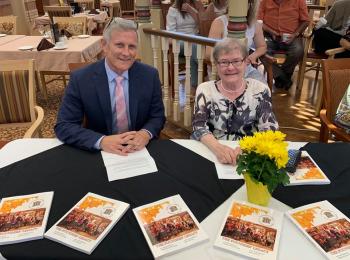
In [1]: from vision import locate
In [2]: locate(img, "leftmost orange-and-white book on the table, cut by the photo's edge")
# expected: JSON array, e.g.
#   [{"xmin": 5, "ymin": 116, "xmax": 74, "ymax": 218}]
[{"xmin": 0, "ymin": 191, "xmax": 53, "ymax": 245}]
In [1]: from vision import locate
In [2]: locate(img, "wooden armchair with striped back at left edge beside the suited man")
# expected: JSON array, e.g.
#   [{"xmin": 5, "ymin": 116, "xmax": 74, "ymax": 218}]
[{"xmin": 0, "ymin": 60, "xmax": 44, "ymax": 138}]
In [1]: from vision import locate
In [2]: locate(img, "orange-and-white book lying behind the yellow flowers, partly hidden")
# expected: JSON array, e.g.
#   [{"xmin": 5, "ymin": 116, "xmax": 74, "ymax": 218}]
[{"xmin": 287, "ymin": 151, "xmax": 331, "ymax": 186}]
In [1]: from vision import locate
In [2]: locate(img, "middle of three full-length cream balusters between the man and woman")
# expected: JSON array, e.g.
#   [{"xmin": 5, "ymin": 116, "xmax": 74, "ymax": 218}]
[{"xmin": 173, "ymin": 39, "xmax": 180, "ymax": 121}]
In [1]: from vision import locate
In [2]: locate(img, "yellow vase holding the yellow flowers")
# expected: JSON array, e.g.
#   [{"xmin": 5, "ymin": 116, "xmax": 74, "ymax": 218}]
[{"xmin": 244, "ymin": 174, "xmax": 271, "ymax": 206}]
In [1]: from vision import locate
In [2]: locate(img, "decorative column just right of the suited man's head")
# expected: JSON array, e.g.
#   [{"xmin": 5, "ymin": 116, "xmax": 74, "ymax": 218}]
[{"xmin": 135, "ymin": 0, "xmax": 153, "ymax": 66}]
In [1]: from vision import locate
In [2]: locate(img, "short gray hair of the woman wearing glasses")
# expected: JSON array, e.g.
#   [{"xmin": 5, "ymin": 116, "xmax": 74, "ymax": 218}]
[{"xmin": 213, "ymin": 38, "xmax": 248, "ymax": 62}]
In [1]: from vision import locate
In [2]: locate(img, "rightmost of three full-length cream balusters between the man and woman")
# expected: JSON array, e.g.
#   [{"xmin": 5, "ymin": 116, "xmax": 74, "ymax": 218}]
[{"xmin": 184, "ymin": 41, "xmax": 192, "ymax": 126}]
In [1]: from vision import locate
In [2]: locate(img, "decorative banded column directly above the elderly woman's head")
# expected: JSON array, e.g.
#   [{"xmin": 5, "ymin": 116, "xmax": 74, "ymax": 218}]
[{"xmin": 227, "ymin": 0, "xmax": 248, "ymax": 39}]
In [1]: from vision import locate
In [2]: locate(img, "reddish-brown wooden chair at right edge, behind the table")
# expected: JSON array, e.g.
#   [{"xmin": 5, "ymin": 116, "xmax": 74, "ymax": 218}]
[{"xmin": 320, "ymin": 58, "xmax": 350, "ymax": 142}]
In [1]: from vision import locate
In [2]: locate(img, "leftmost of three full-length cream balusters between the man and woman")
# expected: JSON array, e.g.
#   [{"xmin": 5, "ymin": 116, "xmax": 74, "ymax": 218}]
[{"xmin": 161, "ymin": 37, "xmax": 170, "ymax": 116}]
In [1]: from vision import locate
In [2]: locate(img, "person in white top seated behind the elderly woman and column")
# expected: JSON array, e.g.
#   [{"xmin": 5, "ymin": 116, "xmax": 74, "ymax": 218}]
[{"xmin": 206, "ymin": 0, "xmax": 267, "ymax": 84}]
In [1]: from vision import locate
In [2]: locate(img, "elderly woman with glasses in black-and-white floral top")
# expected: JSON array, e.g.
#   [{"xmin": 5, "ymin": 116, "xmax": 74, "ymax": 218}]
[{"xmin": 192, "ymin": 38, "xmax": 278, "ymax": 164}]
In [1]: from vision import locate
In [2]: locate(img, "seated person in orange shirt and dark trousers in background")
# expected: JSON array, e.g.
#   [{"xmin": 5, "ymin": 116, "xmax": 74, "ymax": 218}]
[{"xmin": 257, "ymin": 0, "xmax": 309, "ymax": 90}]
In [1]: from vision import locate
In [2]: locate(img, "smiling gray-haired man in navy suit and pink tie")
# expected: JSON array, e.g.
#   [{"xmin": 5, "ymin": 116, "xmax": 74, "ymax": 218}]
[{"xmin": 55, "ymin": 18, "xmax": 165, "ymax": 155}]
